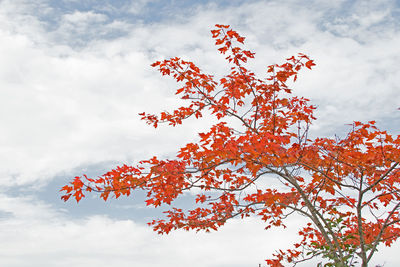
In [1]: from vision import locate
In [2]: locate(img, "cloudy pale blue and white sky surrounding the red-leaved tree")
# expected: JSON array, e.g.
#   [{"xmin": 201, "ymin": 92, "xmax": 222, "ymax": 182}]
[{"xmin": 0, "ymin": 0, "xmax": 400, "ymax": 267}]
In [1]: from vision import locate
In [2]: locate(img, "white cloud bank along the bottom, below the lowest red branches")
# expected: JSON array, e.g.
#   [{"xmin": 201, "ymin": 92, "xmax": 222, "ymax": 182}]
[{"xmin": 0, "ymin": 195, "xmax": 304, "ymax": 267}]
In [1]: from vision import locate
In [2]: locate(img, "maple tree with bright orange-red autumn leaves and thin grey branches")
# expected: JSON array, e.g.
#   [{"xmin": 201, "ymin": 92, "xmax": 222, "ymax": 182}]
[{"xmin": 61, "ymin": 25, "xmax": 400, "ymax": 266}]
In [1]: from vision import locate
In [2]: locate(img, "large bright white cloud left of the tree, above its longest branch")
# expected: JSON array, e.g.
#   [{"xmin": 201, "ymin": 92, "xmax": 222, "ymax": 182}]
[{"xmin": 0, "ymin": 1, "xmax": 222, "ymax": 188}]
